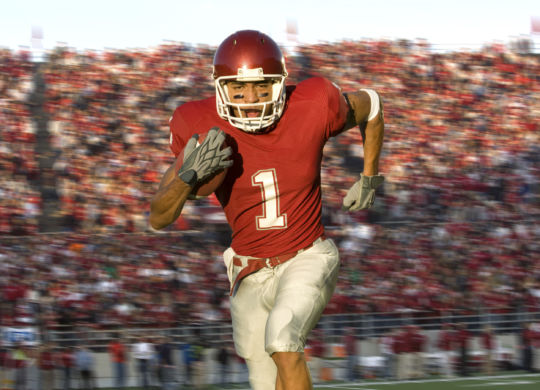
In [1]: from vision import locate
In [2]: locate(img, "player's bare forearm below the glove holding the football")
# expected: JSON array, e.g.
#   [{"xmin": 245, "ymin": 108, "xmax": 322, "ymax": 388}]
[{"xmin": 150, "ymin": 177, "xmax": 192, "ymax": 230}]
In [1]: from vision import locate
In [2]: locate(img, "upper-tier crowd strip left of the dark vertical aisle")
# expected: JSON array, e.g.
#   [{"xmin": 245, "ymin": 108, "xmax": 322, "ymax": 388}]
[{"xmin": 0, "ymin": 49, "xmax": 41, "ymax": 234}]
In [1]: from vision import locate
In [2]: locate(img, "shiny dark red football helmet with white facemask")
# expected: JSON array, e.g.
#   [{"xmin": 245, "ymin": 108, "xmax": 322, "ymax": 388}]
[{"xmin": 213, "ymin": 30, "xmax": 287, "ymax": 132}]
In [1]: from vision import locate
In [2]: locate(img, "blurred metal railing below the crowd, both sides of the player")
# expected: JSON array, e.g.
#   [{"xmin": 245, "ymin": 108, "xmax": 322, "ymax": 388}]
[{"xmin": 41, "ymin": 308, "xmax": 540, "ymax": 350}]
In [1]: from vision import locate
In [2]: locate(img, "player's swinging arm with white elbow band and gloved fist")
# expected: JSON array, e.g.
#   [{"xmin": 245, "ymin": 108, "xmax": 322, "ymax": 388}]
[{"xmin": 343, "ymin": 90, "xmax": 384, "ymax": 211}]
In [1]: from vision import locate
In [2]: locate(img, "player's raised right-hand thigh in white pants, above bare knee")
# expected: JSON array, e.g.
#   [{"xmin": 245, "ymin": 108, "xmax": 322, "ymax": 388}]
[{"xmin": 266, "ymin": 240, "xmax": 339, "ymax": 355}]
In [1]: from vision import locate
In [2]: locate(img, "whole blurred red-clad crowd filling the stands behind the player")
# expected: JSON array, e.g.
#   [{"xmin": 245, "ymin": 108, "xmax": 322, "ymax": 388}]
[{"xmin": 0, "ymin": 41, "xmax": 540, "ymax": 328}]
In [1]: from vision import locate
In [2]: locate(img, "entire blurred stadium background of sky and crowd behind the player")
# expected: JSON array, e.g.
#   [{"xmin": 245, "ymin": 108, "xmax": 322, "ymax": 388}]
[{"xmin": 0, "ymin": 1, "xmax": 540, "ymax": 386}]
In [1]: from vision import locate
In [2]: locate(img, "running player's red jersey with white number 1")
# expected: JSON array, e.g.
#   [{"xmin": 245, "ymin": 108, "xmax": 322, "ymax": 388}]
[{"xmin": 170, "ymin": 77, "xmax": 349, "ymax": 258}]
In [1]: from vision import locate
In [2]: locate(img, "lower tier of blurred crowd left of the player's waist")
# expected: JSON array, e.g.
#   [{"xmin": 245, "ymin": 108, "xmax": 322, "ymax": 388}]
[{"xmin": 0, "ymin": 234, "xmax": 229, "ymax": 331}]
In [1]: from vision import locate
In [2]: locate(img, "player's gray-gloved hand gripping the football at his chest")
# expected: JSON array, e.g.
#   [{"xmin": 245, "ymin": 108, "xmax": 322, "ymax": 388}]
[{"xmin": 178, "ymin": 127, "xmax": 233, "ymax": 186}]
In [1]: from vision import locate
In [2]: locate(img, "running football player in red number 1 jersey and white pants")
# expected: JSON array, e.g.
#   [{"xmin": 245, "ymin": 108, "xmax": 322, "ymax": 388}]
[{"xmin": 150, "ymin": 30, "xmax": 384, "ymax": 390}]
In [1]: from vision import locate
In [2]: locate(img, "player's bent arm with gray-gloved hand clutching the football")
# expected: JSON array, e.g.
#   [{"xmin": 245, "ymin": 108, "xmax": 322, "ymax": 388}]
[{"xmin": 150, "ymin": 128, "xmax": 233, "ymax": 229}]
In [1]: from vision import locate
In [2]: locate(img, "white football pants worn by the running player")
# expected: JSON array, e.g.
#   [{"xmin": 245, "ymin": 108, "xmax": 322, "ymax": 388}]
[{"xmin": 223, "ymin": 239, "xmax": 339, "ymax": 390}]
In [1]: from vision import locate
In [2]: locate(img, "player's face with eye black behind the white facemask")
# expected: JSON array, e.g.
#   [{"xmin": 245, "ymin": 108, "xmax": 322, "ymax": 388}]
[{"xmin": 227, "ymin": 80, "xmax": 273, "ymax": 118}]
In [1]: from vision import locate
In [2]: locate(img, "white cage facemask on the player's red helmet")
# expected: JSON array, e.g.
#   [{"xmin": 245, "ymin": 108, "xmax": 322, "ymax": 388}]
[{"xmin": 215, "ymin": 68, "xmax": 287, "ymax": 133}]
